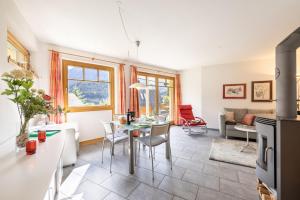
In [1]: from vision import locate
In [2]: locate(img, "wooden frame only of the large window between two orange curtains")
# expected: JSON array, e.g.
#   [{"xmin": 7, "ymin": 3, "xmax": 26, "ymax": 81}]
[{"xmin": 62, "ymin": 60, "xmax": 115, "ymax": 113}]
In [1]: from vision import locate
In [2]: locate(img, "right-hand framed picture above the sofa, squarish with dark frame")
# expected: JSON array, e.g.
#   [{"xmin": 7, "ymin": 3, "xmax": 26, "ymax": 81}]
[{"xmin": 251, "ymin": 81, "xmax": 273, "ymax": 102}]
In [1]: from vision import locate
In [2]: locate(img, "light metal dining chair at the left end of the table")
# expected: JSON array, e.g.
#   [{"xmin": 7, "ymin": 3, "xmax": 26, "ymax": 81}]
[{"xmin": 102, "ymin": 122, "xmax": 128, "ymax": 173}]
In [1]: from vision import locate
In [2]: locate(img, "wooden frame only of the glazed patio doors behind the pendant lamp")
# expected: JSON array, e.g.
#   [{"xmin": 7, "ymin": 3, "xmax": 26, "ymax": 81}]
[{"xmin": 137, "ymin": 71, "xmax": 175, "ymax": 122}]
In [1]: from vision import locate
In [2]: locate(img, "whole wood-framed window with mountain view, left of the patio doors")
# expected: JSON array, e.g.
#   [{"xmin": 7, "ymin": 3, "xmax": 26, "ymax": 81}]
[{"xmin": 63, "ymin": 60, "xmax": 114, "ymax": 112}]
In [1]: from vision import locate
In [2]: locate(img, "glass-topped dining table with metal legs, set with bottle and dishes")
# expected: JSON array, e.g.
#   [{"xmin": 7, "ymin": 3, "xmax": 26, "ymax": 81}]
[{"xmin": 113, "ymin": 120, "xmax": 170, "ymax": 174}]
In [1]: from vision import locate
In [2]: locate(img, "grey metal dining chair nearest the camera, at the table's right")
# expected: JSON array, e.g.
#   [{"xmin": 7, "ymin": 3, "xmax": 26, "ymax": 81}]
[{"xmin": 136, "ymin": 123, "xmax": 172, "ymax": 180}]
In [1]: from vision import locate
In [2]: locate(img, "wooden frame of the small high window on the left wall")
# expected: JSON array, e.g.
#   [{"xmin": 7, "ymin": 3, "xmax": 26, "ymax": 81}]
[{"xmin": 6, "ymin": 31, "xmax": 30, "ymax": 69}]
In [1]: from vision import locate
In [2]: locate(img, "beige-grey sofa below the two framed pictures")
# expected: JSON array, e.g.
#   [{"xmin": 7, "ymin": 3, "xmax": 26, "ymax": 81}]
[{"xmin": 219, "ymin": 108, "xmax": 275, "ymax": 139}]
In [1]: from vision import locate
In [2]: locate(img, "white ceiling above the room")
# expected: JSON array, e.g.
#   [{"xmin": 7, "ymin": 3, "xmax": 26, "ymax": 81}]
[{"xmin": 15, "ymin": 0, "xmax": 300, "ymax": 69}]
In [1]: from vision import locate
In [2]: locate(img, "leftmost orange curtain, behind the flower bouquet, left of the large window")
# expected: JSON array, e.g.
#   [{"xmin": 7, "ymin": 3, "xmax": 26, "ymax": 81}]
[{"xmin": 50, "ymin": 51, "xmax": 64, "ymax": 124}]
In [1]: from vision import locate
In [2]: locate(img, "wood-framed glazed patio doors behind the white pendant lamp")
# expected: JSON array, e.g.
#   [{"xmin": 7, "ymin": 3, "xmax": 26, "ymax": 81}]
[{"xmin": 138, "ymin": 72, "xmax": 174, "ymax": 120}]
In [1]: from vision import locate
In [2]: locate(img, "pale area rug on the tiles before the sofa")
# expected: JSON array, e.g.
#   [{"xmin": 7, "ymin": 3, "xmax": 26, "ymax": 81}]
[{"xmin": 209, "ymin": 138, "xmax": 257, "ymax": 168}]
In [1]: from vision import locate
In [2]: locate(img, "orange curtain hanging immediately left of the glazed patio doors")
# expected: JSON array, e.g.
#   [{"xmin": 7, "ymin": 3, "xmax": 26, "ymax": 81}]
[{"xmin": 129, "ymin": 65, "xmax": 140, "ymax": 117}]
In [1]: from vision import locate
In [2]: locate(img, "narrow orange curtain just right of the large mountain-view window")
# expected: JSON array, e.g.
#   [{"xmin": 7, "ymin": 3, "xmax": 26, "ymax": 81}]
[{"xmin": 119, "ymin": 64, "xmax": 126, "ymax": 114}]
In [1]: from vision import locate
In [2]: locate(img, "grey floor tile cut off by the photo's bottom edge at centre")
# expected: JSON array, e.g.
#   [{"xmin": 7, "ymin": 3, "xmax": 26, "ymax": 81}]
[{"xmin": 129, "ymin": 183, "xmax": 172, "ymax": 200}]
